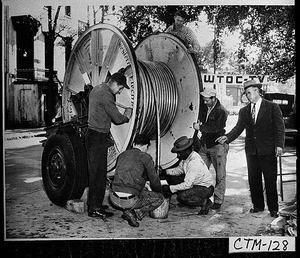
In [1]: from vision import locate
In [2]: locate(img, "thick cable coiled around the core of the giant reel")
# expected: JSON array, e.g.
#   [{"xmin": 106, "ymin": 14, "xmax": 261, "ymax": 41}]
[{"xmin": 137, "ymin": 60, "xmax": 178, "ymax": 139}]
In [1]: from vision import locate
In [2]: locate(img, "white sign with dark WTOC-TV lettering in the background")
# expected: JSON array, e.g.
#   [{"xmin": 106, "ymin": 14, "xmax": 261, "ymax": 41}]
[{"xmin": 202, "ymin": 73, "xmax": 269, "ymax": 85}]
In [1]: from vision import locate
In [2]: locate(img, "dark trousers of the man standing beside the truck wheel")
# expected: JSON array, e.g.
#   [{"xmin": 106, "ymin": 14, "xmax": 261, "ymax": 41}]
[{"xmin": 85, "ymin": 129, "xmax": 109, "ymax": 211}]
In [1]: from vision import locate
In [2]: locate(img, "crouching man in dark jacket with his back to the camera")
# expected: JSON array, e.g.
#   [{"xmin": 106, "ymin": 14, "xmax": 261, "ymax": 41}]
[{"xmin": 110, "ymin": 135, "xmax": 164, "ymax": 227}]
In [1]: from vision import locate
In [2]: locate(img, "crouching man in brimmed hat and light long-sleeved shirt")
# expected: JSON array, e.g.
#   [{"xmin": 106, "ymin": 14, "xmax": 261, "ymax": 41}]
[{"xmin": 161, "ymin": 136, "xmax": 214, "ymax": 215}]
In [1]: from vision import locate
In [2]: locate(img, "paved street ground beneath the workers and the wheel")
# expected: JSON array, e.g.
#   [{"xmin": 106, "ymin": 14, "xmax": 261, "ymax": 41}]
[{"xmin": 5, "ymin": 116, "xmax": 296, "ymax": 239}]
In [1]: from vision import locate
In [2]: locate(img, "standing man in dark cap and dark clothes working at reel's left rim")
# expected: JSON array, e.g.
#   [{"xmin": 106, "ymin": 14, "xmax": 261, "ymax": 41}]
[{"xmin": 85, "ymin": 73, "xmax": 132, "ymax": 221}]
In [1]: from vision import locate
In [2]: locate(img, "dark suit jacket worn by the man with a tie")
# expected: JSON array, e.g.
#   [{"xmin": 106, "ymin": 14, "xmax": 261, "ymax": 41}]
[{"xmin": 226, "ymin": 99, "xmax": 284, "ymax": 155}]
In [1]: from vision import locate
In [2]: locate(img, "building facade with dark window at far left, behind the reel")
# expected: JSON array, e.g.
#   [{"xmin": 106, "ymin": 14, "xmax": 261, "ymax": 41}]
[{"xmin": 2, "ymin": 5, "xmax": 84, "ymax": 128}]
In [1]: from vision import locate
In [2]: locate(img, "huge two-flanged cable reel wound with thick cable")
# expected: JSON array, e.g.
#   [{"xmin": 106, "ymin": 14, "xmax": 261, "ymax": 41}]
[{"xmin": 63, "ymin": 24, "xmax": 202, "ymax": 170}]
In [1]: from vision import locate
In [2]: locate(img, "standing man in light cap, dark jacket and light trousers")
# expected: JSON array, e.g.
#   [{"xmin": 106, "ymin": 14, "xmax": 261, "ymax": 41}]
[{"xmin": 194, "ymin": 88, "xmax": 229, "ymax": 209}]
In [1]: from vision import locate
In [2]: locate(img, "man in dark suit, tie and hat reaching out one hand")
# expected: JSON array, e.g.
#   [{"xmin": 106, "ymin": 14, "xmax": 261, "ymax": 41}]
[{"xmin": 217, "ymin": 80, "xmax": 284, "ymax": 217}]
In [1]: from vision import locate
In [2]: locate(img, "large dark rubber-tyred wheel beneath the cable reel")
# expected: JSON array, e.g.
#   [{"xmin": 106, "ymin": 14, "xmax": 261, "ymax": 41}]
[{"xmin": 42, "ymin": 133, "xmax": 88, "ymax": 206}]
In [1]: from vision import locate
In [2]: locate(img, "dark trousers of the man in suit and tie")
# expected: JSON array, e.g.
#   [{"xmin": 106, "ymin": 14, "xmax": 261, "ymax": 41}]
[{"xmin": 246, "ymin": 153, "xmax": 278, "ymax": 211}]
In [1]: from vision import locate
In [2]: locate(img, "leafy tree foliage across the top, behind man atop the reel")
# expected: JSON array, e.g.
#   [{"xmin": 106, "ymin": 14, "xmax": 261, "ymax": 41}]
[{"xmin": 121, "ymin": 5, "xmax": 296, "ymax": 81}]
